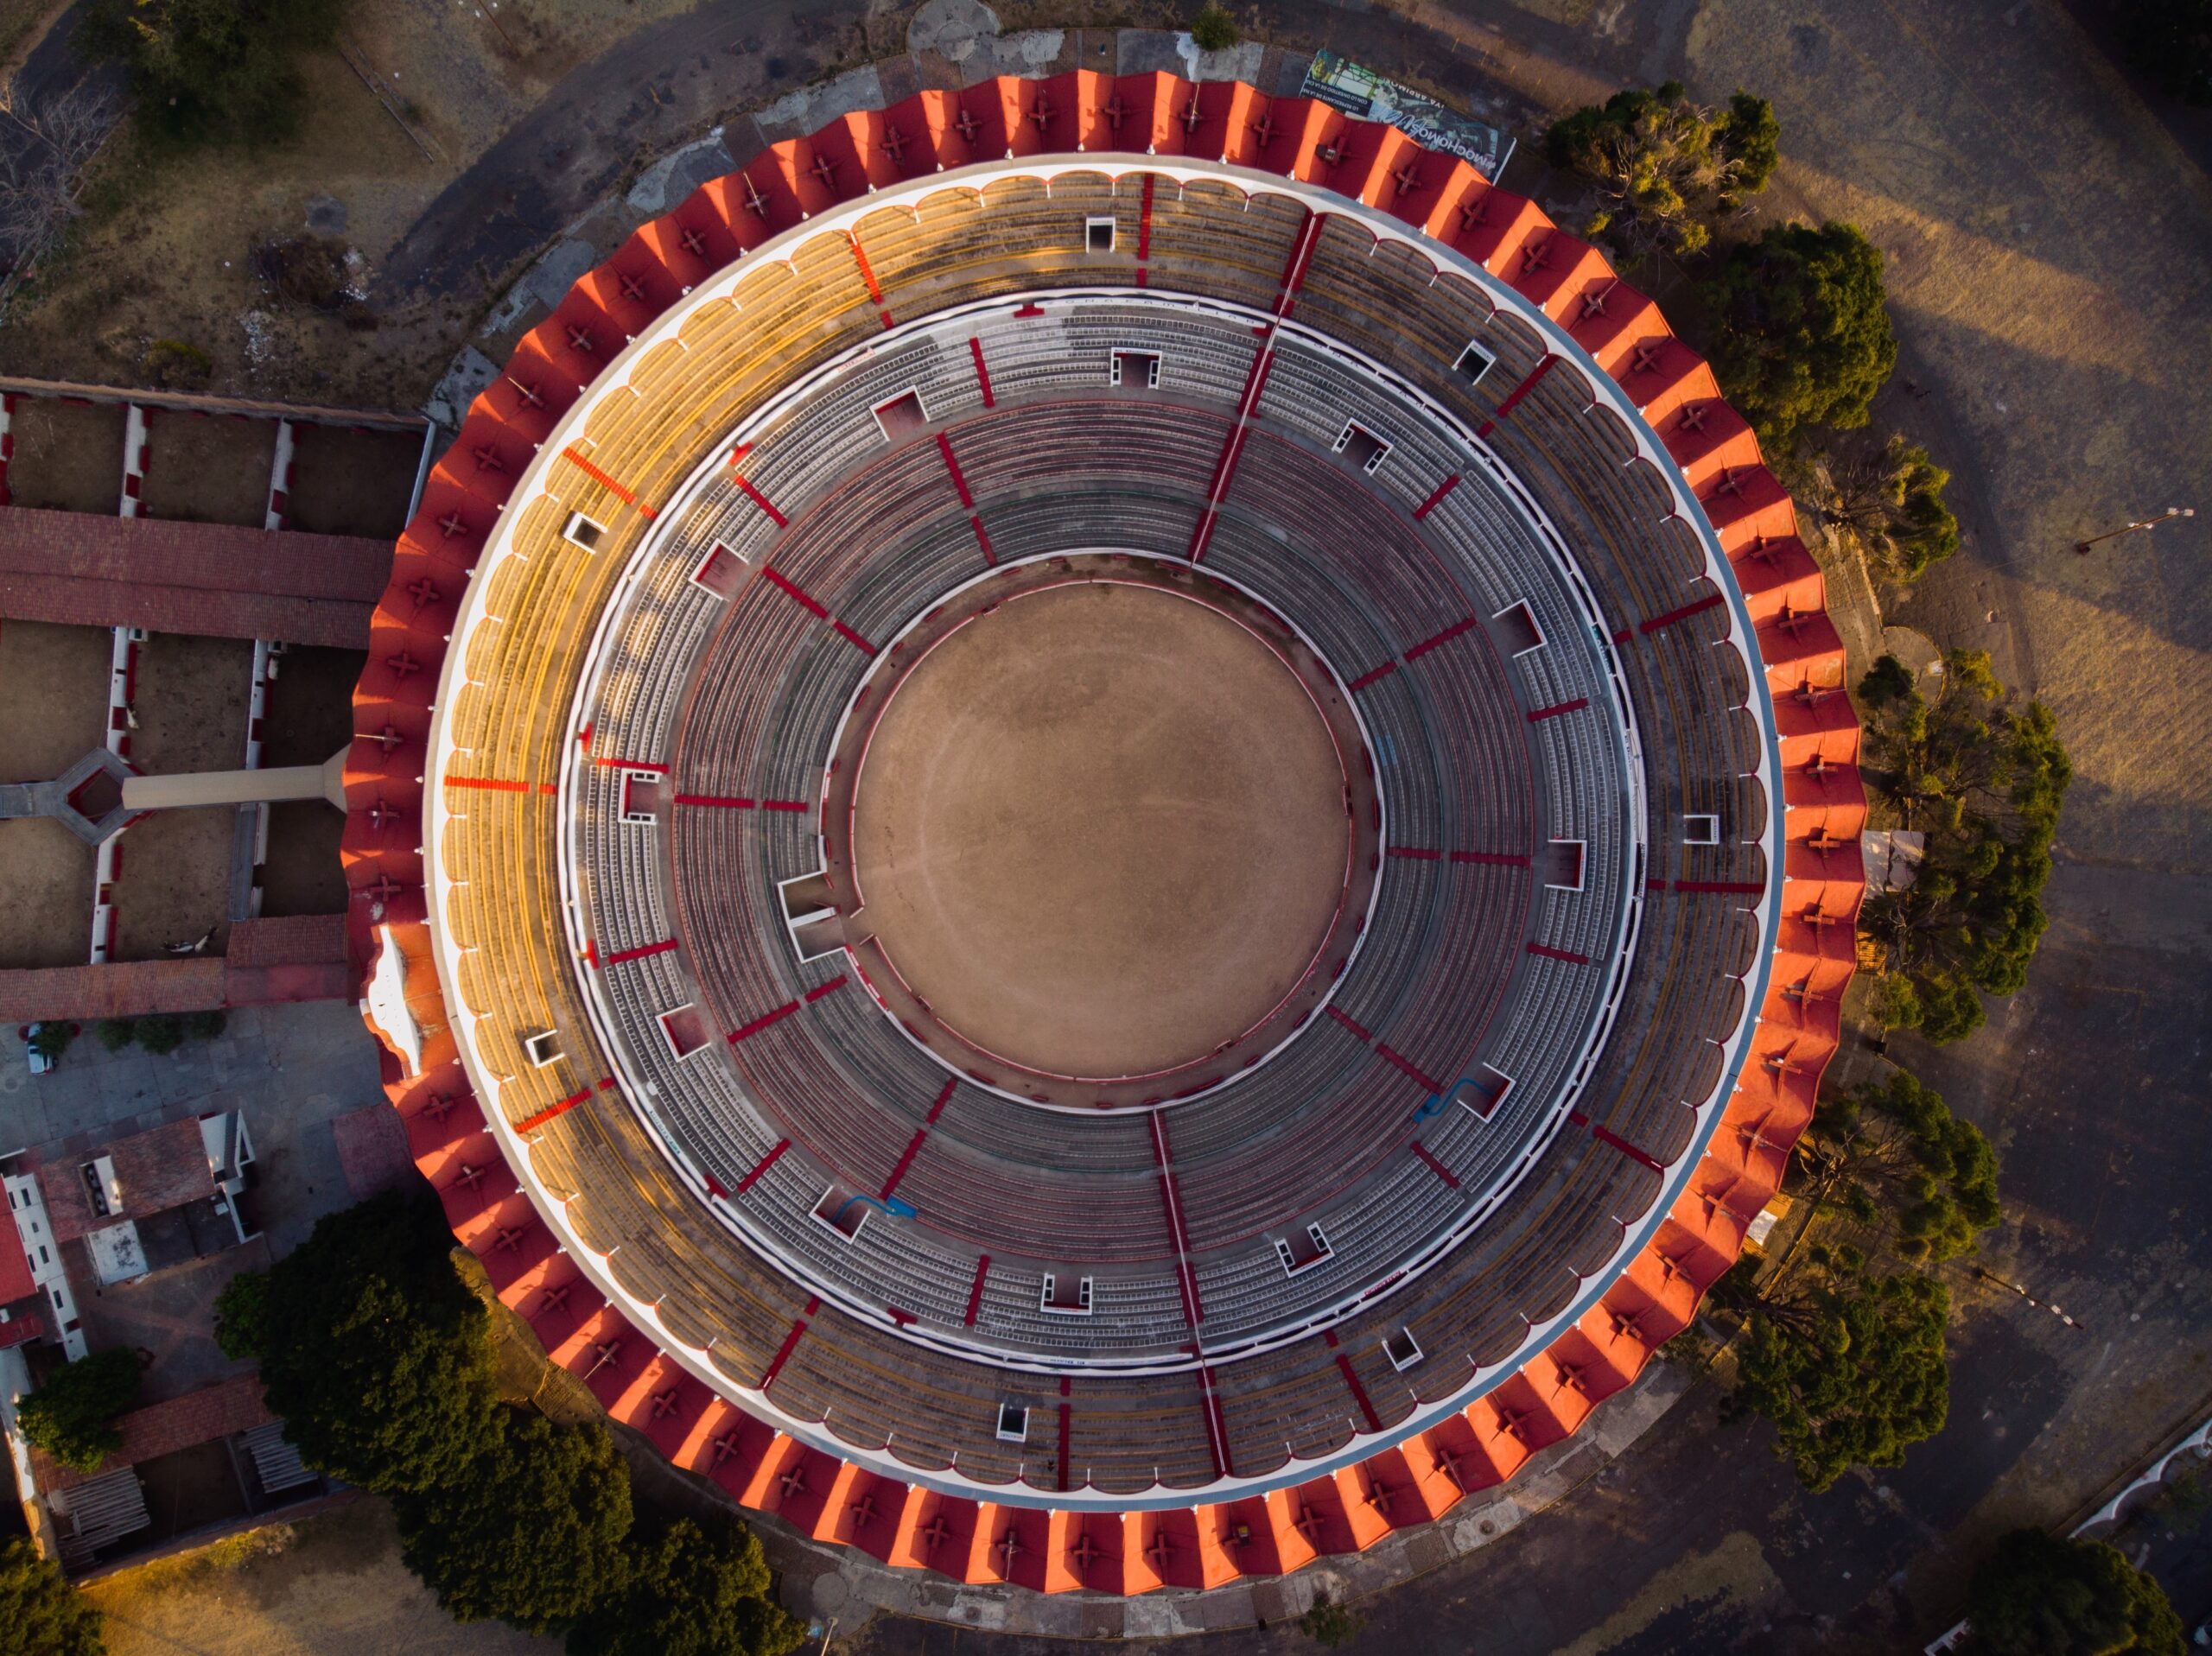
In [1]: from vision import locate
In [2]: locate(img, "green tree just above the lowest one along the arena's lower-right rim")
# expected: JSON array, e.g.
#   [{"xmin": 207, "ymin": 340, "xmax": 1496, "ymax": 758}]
[{"xmin": 1808, "ymin": 1070, "xmax": 2002, "ymax": 1265}]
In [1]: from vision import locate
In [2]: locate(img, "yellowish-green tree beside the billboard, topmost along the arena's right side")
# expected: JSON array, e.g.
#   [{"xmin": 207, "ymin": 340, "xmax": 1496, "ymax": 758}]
[{"xmin": 1544, "ymin": 79, "xmax": 1781, "ymax": 254}]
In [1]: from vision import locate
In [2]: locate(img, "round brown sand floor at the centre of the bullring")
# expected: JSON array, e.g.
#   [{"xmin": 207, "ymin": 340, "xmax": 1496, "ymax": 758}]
[{"xmin": 854, "ymin": 584, "xmax": 1350, "ymax": 1076}]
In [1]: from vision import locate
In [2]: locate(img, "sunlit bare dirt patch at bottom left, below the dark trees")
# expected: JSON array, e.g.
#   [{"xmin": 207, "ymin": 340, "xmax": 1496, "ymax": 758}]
[{"xmin": 84, "ymin": 1497, "xmax": 560, "ymax": 1656}]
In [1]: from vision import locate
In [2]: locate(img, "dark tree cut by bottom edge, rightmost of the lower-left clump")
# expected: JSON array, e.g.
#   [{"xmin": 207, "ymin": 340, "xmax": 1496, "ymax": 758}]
[{"xmin": 569, "ymin": 1519, "xmax": 805, "ymax": 1656}]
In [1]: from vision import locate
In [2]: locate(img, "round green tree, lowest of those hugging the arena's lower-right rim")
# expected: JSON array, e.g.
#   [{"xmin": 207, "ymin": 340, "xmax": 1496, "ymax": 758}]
[{"xmin": 1721, "ymin": 1242, "xmax": 1951, "ymax": 1494}]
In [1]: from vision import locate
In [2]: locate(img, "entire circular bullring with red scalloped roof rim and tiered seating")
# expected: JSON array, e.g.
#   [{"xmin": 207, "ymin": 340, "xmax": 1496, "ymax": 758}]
[{"xmin": 345, "ymin": 73, "xmax": 1865, "ymax": 1592}]
